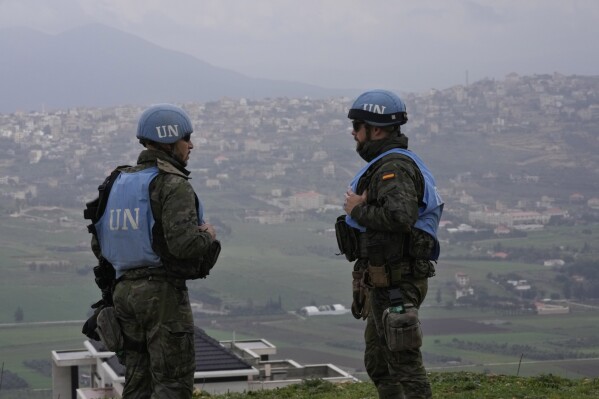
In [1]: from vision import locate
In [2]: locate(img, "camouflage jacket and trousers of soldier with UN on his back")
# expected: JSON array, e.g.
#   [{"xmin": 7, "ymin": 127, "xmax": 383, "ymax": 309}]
[{"xmin": 92, "ymin": 150, "xmax": 212, "ymax": 399}]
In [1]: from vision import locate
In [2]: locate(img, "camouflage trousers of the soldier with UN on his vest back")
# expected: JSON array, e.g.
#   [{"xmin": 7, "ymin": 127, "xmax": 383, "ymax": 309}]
[{"xmin": 113, "ymin": 270, "xmax": 195, "ymax": 399}]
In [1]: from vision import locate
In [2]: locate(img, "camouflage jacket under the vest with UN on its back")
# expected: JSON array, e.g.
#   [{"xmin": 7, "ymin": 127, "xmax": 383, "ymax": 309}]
[{"xmin": 92, "ymin": 150, "xmax": 212, "ymax": 263}]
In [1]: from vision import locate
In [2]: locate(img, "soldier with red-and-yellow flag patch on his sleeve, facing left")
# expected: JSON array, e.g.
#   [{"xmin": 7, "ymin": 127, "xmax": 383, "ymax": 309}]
[{"xmin": 335, "ymin": 90, "xmax": 443, "ymax": 399}]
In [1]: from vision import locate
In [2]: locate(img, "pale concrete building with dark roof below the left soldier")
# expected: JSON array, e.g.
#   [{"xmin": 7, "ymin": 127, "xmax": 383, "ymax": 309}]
[{"xmin": 52, "ymin": 327, "xmax": 358, "ymax": 399}]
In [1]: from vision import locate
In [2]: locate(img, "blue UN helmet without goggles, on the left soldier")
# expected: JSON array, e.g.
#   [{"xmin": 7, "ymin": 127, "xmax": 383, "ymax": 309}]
[{"xmin": 137, "ymin": 104, "xmax": 193, "ymax": 144}]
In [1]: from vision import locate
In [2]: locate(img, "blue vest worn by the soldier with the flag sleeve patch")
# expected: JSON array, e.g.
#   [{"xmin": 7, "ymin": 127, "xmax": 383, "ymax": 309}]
[{"xmin": 345, "ymin": 148, "xmax": 444, "ymax": 260}]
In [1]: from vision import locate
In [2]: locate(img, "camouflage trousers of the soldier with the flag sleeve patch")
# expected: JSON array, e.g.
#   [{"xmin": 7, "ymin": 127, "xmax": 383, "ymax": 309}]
[{"xmin": 364, "ymin": 276, "xmax": 432, "ymax": 399}]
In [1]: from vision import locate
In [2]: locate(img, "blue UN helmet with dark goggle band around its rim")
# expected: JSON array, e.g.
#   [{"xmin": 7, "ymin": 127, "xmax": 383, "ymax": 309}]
[{"xmin": 347, "ymin": 90, "xmax": 408, "ymax": 126}]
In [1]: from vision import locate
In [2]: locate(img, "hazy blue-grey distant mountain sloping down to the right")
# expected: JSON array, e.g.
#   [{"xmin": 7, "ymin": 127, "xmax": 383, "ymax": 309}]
[{"xmin": 0, "ymin": 24, "xmax": 355, "ymax": 113}]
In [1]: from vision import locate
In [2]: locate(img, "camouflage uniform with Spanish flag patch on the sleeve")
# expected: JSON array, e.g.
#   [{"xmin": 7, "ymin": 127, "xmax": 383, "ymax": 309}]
[{"xmin": 351, "ymin": 135, "xmax": 434, "ymax": 399}]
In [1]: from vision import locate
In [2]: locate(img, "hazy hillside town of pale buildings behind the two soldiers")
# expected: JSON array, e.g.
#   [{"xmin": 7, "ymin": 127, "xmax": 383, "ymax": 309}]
[{"xmin": 0, "ymin": 74, "xmax": 599, "ymax": 223}]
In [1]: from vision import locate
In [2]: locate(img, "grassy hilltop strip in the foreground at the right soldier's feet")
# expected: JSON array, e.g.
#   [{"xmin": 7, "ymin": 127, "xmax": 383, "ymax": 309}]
[{"xmin": 194, "ymin": 372, "xmax": 599, "ymax": 399}]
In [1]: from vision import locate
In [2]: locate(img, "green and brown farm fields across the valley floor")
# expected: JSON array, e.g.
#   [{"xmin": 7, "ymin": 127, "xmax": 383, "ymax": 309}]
[{"xmin": 0, "ymin": 209, "xmax": 599, "ymax": 397}]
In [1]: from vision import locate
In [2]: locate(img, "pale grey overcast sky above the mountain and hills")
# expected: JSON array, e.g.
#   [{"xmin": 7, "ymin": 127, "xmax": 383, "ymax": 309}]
[{"xmin": 0, "ymin": 0, "xmax": 599, "ymax": 91}]
